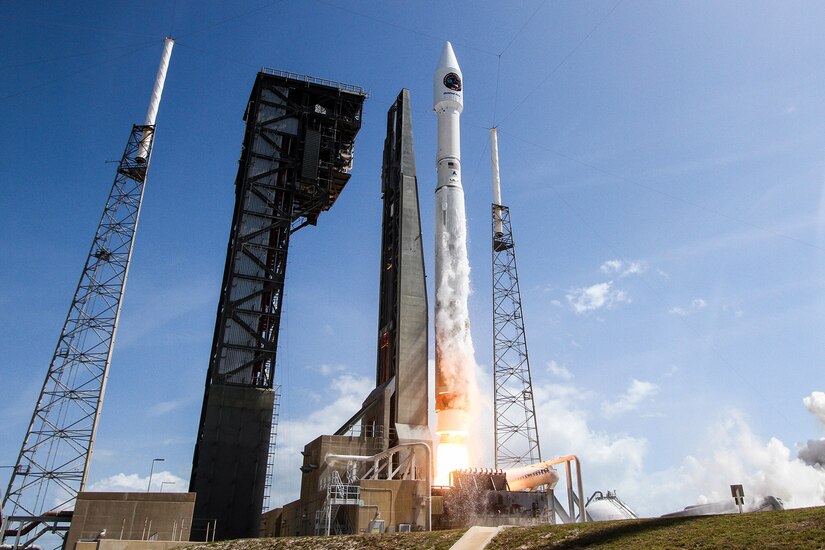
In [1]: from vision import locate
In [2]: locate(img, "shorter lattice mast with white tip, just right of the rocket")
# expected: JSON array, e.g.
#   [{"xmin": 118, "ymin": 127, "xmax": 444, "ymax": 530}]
[{"xmin": 490, "ymin": 128, "xmax": 541, "ymax": 468}]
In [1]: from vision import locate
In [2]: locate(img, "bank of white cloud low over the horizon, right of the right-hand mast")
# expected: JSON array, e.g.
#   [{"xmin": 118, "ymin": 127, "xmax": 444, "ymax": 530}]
[{"xmin": 534, "ymin": 383, "xmax": 825, "ymax": 517}]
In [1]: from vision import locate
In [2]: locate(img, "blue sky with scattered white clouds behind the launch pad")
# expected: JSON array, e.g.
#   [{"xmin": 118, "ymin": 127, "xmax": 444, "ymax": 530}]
[{"xmin": 0, "ymin": 0, "xmax": 825, "ymax": 515}]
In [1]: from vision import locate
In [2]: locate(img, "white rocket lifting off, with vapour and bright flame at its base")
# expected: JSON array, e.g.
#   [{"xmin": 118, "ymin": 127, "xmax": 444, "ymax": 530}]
[{"xmin": 433, "ymin": 42, "xmax": 475, "ymax": 485}]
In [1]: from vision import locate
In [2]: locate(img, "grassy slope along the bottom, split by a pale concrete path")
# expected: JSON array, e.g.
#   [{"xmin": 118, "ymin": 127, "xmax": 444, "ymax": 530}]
[{"xmin": 185, "ymin": 507, "xmax": 825, "ymax": 550}]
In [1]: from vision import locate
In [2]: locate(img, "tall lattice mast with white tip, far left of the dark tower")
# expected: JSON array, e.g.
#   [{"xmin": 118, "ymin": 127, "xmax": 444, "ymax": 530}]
[{"xmin": 0, "ymin": 38, "xmax": 174, "ymax": 548}]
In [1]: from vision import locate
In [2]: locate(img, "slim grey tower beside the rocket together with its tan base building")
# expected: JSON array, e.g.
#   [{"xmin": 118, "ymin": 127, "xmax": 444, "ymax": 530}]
[{"xmin": 274, "ymin": 90, "xmax": 432, "ymax": 536}]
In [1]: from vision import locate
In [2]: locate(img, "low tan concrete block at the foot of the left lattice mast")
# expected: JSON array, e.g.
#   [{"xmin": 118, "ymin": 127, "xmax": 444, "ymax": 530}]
[{"xmin": 65, "ymin": 492, "xmax": 195, "ymax": 550}]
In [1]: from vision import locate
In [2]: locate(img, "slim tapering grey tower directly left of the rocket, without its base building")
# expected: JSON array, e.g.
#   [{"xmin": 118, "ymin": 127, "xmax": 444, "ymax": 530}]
[{"xmin": 337, "ymin": 89, "xmax": 431, "ymax": 450}]
